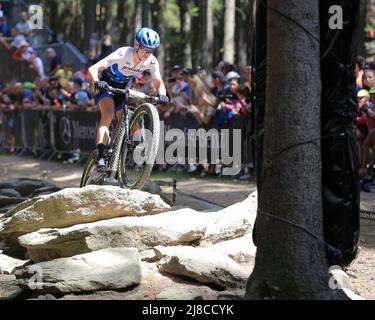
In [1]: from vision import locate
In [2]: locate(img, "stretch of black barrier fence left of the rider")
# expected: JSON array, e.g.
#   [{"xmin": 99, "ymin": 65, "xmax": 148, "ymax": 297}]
[{"xmin": 0, "ymin": 110, "xmax": 100, "ymax": 157}]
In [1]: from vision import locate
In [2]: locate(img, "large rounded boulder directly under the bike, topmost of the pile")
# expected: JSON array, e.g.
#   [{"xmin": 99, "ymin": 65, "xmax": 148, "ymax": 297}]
[{"xmin": 0, "ymin": 186, "xmax": 170, "ymax": 252}]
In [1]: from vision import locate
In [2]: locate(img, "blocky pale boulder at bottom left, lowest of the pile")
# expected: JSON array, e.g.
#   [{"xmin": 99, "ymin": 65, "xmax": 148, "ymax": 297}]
[{"xmin": 15, "ymin": 248, "xmax": 142, "ymax": 294}]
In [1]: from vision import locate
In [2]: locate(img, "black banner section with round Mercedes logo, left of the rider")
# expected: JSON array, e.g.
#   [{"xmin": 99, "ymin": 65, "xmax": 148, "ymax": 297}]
[{"xmin": 53, "ymin": 111, "xmax": 100, "ymax": 153}]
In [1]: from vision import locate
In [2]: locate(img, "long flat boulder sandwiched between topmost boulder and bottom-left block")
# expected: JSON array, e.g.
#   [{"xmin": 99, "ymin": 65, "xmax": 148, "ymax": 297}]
[{"xmin": 19, "ymin": 209, "xmax": 207, "ymax": 262}]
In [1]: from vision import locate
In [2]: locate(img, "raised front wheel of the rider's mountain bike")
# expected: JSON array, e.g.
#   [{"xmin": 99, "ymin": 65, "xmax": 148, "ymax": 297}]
[{"xmin": 118, "ymin": 103, "xmax": 160, "ymax": 189}]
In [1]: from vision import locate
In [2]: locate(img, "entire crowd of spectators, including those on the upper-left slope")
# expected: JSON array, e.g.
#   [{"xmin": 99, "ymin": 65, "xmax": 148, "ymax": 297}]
[{"xmin": 0, "ymin": 4, "xmax": 251, "ymax": 179}]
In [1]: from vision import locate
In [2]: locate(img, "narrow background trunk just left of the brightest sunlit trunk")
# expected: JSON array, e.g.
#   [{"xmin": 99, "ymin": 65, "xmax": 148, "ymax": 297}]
[{"xmin": 201, "ymin": 0, "xmax": 214, "ymax": 69}]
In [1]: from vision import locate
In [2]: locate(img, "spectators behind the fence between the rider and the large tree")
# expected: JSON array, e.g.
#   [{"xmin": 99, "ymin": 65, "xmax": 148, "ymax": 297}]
[{"xmin": 159, "ymin": 61, "xmax": 252, "ymax": 180}]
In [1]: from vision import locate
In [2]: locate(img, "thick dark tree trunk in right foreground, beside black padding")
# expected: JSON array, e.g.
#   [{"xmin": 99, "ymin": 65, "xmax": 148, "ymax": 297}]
[{"xmin": 246, "ymin": 0, "xmax": 344, "ymax": 299}]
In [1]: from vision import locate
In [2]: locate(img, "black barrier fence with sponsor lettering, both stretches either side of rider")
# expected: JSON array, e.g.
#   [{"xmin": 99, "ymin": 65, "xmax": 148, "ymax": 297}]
[{"xmin": 0, "ymin": 109, "xmax": 251, "ymax": 166}]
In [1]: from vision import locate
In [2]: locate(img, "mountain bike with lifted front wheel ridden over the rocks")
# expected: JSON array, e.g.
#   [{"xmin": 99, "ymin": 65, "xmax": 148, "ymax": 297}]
[{"xmin": 80, "ymin": 86, "xmax": 160, "ymax": 189}]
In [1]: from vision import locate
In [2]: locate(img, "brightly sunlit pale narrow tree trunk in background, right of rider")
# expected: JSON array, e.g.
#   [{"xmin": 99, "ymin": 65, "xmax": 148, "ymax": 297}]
[{"xmin": 224, "ymin": 0, "xmax": 236, "ymax": 63}]
